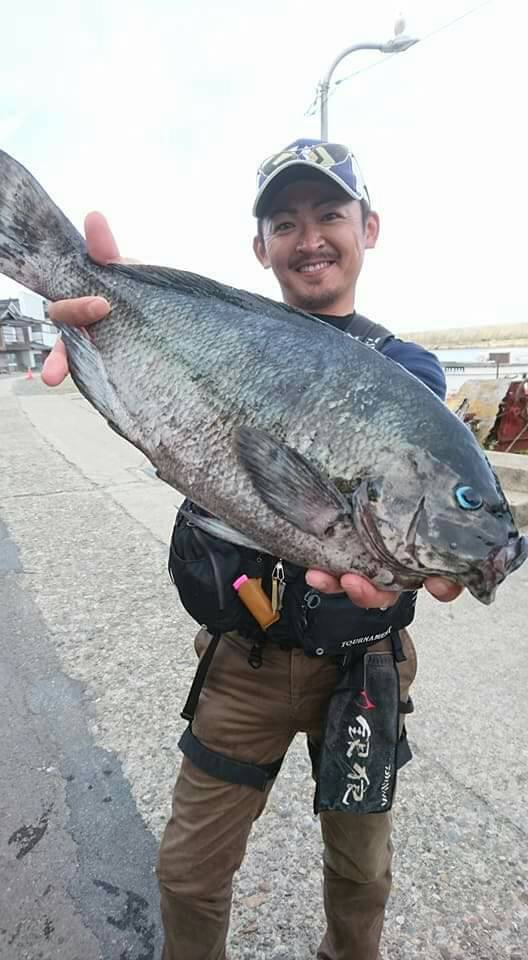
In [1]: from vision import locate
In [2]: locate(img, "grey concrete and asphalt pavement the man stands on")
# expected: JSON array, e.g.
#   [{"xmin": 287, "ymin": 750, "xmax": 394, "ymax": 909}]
[{"xmin": 0, "ymin": 379, "xmax": 528, "ymax": 960}]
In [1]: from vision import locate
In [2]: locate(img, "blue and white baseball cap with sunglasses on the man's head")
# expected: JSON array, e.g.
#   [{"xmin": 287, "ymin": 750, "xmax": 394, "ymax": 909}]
[{"xmin": 253, "ymin": 140, "xmax": 370, "ymax": 217}]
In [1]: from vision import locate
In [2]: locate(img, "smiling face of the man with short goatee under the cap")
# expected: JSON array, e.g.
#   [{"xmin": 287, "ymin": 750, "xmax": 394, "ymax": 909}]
[{"xmin": 254, "ymin": 177, "xmax": 379, "ymax": 315}]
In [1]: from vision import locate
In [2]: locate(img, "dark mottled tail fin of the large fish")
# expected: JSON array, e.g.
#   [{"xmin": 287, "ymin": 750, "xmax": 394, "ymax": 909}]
[{"xmin": 0, "ymin": 150, "xmax": 85, "ymax": 297}]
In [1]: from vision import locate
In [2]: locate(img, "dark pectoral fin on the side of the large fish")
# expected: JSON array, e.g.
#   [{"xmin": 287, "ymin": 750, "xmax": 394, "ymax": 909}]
[{"xmin": 236, "ymin": 427, "xmax": 352, "ymax": 537}]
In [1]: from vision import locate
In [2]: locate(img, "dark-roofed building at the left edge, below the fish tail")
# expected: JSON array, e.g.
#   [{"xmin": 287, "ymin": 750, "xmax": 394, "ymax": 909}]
[{"xmin": 0, "ymin": 298, "xmax": 57, "ymax": 374}]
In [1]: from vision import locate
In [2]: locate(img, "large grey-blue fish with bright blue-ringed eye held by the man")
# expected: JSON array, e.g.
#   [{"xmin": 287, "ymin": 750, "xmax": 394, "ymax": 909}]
[{"xmin": 0, "ymin": 152, "xmax": 528, "ymax": 603}]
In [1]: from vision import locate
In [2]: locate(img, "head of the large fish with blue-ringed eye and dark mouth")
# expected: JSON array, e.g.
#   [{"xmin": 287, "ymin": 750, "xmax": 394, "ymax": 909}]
[{"xmin": 352, "ymin": 449, "xmax": 528, "ymax": 604}]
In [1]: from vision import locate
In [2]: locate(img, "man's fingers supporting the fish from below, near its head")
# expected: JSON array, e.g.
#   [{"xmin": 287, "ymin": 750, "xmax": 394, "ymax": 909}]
[{"xmin": 306, "ymin": 570, "xmax": 463, "ymax": 609}]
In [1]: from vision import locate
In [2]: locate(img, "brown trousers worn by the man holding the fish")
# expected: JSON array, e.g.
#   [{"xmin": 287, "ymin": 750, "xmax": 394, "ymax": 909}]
[{"xmin": 158, "ymin": 630, "xmax": 416, "ymax": 960}]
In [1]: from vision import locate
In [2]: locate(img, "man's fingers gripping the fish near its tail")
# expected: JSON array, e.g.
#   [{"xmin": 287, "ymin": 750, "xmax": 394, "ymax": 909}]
[{"xmin": 42, "ymin": 213, "xmax": 122, "ymax": 387}]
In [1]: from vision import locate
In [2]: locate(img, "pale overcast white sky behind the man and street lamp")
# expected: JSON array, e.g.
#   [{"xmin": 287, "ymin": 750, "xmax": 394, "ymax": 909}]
[{"xmin": 0, "ymin": 0, "xmax": 528, "ymax": 333}]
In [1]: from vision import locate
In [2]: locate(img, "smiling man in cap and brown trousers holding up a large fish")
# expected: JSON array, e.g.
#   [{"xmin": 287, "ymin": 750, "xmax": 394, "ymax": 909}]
[{"xmin": 44, "ymin": 140, "xmax": 460, "ymax": 960}]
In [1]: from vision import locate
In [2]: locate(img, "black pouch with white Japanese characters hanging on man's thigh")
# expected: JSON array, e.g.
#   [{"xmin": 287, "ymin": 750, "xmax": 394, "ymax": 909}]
[{"xmin": 314, "ymin": 653, "xmax": 400, "ymax": 814}]
